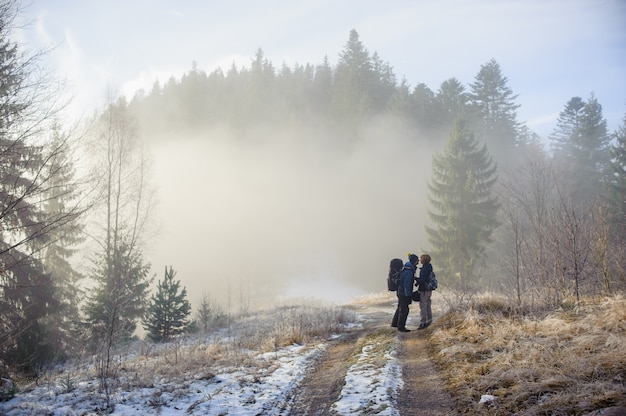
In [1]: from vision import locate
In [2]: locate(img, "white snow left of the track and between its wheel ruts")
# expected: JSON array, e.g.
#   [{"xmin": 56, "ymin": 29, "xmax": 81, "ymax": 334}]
[{"xmin": 0, "ymin": 306, "xmax": 402, "ymax": 416}]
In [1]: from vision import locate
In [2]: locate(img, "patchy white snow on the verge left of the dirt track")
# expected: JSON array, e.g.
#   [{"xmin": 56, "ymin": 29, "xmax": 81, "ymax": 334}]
[{"xmin": 0, "ymin": 344, "xmax": 325, "ymax": 416}]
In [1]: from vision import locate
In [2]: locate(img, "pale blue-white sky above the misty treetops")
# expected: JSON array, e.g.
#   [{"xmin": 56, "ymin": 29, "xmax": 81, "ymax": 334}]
[{"xmin": 17, "ymin": 0, "xmax": 626, "ymax": 136}]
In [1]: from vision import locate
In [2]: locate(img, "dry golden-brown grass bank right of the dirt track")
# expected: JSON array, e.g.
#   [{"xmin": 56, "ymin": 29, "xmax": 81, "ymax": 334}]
[{"xmin": 431, "ymin": 295, "xmax": 626, "ymax": 415}]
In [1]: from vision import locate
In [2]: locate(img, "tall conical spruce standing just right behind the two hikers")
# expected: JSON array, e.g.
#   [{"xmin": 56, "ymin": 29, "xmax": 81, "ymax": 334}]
[{"xmin": 426, "ymin": 118, "xmax": 498, "ymax": 286}]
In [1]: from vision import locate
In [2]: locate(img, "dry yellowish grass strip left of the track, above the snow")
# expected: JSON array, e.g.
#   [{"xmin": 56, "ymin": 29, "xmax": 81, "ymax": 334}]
[{"xmin": 91, "ymin": 305, "xmax": 355, "ymax": 391}]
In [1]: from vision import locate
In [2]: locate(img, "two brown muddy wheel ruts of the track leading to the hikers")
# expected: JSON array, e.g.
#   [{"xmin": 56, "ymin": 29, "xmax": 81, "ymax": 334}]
[{"xmin": 289, "ymin": 307, "xmax": 459, "ymax": 416}]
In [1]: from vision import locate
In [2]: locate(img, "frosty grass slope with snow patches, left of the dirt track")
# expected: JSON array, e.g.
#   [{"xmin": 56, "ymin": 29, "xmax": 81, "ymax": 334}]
[{"xmin": 0, "ymin": 302, "xmax": 349, "ymax": 416}]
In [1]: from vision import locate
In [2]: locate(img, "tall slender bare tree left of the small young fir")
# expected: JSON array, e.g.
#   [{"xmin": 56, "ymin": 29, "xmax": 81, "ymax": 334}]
[{"xmin": 86, "ymin": 95, "xmax": 153, "ymax": 389}]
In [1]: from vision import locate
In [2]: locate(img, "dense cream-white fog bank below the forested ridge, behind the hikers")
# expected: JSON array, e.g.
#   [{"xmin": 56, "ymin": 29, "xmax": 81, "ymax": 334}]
[{"xmin": 147, "ymin": 127, "xmax": 431, "ymax": 310}]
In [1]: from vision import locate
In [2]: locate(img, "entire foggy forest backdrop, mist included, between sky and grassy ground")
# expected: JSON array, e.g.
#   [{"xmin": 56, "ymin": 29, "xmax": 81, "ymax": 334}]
[{"xmin": 0, "ymin": 0, "xmax": 626, "ymax": 381}]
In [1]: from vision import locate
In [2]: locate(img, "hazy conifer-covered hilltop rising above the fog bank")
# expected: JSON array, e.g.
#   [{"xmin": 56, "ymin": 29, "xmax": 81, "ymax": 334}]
[{"xmin": 124, "ymin": 30, "xmax": 528, "ymax": 159}]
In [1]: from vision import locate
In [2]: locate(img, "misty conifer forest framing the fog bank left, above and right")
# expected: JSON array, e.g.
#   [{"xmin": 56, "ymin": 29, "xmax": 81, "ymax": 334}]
[{"xmin": 0, "ymin": 0, "xmax": 626, "ymax": 391}]
